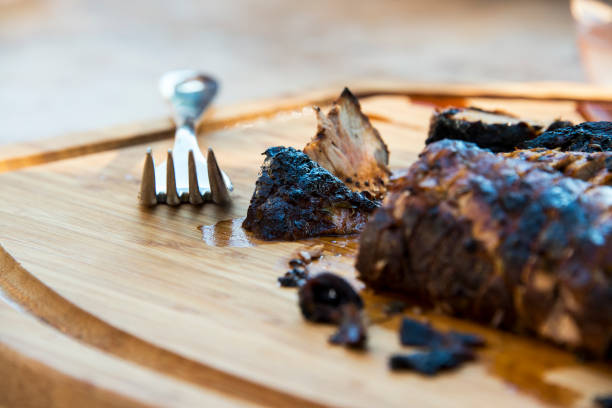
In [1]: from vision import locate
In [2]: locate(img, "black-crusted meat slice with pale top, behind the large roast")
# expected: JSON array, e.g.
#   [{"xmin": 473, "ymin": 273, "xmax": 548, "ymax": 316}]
[{"xmin": 425, "ymin": 107, "xmax": 571, "ymax": 153}]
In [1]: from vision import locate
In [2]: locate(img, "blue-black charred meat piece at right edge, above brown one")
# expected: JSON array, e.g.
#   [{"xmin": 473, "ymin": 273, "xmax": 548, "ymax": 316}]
[{"xmin": 523, "ymin": 122, "xmax": 612, "ymax": 153}]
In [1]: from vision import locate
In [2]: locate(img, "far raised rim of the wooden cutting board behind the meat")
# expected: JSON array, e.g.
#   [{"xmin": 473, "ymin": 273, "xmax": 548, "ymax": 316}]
[{"xmin": 0, "ymin": 79, "xmax": 612, "ymax": 172}]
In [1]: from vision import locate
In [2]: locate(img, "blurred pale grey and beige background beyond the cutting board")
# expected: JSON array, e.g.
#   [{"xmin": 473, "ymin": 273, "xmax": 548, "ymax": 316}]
[{"xmin": 0, "ymin": 0, "xmax": 612, "ymax": 144}]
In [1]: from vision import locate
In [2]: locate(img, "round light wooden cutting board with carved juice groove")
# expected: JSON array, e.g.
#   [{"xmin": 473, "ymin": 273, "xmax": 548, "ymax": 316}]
[{"xmin": 0, "ymin": 83, "xmax": 612, "ymax": 407}]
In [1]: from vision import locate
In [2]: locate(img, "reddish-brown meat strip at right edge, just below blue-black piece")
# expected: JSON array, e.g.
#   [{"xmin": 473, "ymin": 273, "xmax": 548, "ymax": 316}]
[{"xmin": 502, "ymin": 148, "xmax": 612, "ymax": 186}]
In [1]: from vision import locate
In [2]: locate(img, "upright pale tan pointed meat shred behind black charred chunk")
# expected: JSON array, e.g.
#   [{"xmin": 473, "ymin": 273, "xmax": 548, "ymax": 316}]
[{"xmin": 304, "ymin": 88, "xmax": 390, "ymax": 198}]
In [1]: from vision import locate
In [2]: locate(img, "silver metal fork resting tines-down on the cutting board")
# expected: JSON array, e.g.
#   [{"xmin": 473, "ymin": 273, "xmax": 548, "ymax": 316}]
[{"xmin": 140, "ymin": 70, "xmax": 233, "ymax": 206}]
